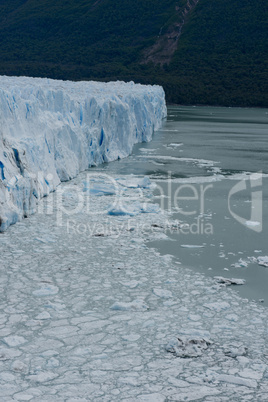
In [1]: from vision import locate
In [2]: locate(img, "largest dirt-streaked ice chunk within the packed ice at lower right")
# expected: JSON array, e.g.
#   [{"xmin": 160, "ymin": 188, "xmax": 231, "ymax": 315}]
[{"xmin": 166, "ymin": 336, "xmax": 212, "ymax": 358}]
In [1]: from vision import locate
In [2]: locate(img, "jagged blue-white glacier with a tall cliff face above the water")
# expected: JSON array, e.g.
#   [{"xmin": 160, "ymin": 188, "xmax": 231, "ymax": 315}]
[{"xmin": 0, "ymin": 77, "xmax": 166, "ymax": 231}]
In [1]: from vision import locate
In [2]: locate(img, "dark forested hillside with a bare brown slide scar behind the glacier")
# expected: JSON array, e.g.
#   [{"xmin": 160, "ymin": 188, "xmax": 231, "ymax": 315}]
[{"xmin": 0, "ymin": 0, "xmax": 268, "ymax": 106}]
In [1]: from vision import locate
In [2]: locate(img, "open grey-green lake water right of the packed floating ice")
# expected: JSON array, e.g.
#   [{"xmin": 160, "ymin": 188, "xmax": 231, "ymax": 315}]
[{"xmin": 97, "ymin": 106, "xmax": 268, "ymax": 305}]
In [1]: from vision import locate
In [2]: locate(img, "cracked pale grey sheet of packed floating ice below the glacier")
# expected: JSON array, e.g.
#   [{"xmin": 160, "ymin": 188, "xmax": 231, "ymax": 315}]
[{"xmin": 0, "ymin": 103, "xmax": 268, "ymax": 402}]
